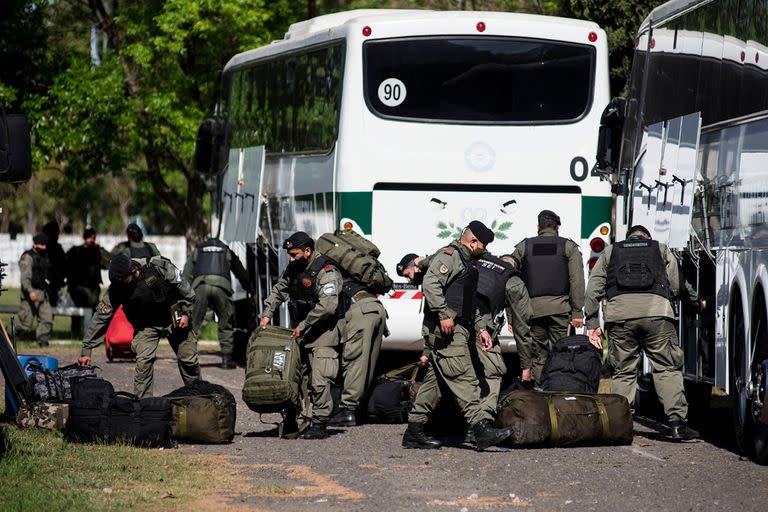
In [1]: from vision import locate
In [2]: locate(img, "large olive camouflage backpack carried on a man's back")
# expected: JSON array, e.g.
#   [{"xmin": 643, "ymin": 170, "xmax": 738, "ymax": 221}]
[{"xmin": 315, "ymin": 230, "xmax": 392, "ymax": 294}]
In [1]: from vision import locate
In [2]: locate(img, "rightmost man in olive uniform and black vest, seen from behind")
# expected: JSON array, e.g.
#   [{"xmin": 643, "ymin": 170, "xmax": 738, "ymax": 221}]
[{"xmin": 585, "ymin": 225, "xmax": 705, "ymax": 441}]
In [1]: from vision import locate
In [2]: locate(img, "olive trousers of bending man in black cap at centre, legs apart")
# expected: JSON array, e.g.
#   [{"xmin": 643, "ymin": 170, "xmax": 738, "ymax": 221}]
[{"xmin": 408, "ymin": 325, "xmax": 496, "ymax": 426}]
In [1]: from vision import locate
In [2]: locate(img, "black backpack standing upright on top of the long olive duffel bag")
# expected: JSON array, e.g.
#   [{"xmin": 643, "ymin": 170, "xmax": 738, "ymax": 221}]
[{"xmin": 541, "ymin": 334, "xmax": 602, "ymax": 393}]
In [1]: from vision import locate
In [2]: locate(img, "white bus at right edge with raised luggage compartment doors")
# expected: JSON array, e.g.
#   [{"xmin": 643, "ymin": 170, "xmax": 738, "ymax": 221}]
[{"xmin": 592, "ymin": 0, "xmax": 768, "ymax": 463}]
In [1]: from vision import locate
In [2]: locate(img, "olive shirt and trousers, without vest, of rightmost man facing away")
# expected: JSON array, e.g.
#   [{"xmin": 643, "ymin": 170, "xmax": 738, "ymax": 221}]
[{"xmin": 584, "ymin": 239, "xmax": 699, "ymax": 421}]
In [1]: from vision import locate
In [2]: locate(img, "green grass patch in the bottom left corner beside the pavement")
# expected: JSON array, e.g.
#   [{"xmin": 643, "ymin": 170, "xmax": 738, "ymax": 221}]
[{"xmin": 0, "ymin": 424, "xmax": 234, "ymax": 512}]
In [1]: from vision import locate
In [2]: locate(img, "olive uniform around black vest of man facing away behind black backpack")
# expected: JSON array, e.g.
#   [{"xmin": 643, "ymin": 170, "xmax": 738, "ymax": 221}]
[{"xmin": 512, "ymin": 228, "xmax": 584, "ymax": 382}]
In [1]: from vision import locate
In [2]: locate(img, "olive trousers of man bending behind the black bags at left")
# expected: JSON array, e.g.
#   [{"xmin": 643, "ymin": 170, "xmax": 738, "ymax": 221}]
[{"xmin": 131, "ymin": 327, "xmax": 200, "ymax": 398}]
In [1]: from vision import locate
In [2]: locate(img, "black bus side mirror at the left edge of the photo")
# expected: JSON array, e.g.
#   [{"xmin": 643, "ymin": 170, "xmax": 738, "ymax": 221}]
[{"xmin": 0, "ymin": 111, "xmax": 32, "ymax": 183}]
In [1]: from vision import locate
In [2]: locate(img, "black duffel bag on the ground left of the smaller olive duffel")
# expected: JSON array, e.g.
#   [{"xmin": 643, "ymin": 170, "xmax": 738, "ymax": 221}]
[{"xmin": 64, "ymin": 379, "xmax": 173, "ymax": 447}]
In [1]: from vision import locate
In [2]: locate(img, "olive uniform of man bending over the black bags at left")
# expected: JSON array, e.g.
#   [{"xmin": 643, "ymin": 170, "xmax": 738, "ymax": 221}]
[{"xmin": 81, "ymin": 256, "xmax": 200, "ymax": 398}]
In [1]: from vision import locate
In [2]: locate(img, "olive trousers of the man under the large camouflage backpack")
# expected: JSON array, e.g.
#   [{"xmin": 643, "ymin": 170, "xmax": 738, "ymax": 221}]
[{"xmin": 340, "ymin": 298, "xmax": 387, "ymax": 411}]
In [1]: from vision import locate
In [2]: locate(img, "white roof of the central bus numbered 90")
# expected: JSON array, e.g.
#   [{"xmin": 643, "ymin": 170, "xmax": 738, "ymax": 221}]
[{"xmin": 224, "ymin": 9, "xmax": 600, "ymax": 72}]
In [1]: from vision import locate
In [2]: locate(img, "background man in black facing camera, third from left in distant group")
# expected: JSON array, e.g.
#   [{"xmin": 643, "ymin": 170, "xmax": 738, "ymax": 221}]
[{"xmin": 67, "ymin": 227, "xmax": 109, "ymax": 335}]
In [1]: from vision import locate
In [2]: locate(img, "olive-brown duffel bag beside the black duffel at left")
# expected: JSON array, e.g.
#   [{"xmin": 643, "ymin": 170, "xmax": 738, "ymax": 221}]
[{"xmin": 165, "ymin": 380, "xmax": 237, "ymax": 444}]
